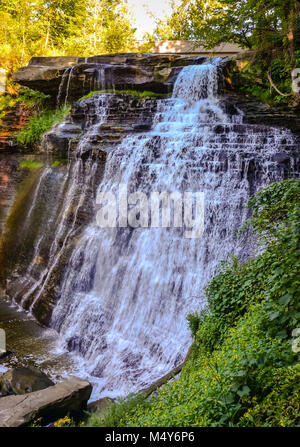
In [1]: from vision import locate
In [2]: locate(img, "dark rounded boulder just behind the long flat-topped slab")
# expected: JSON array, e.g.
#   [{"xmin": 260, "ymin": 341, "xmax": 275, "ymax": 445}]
[{"xmin": 0, "ymin": 368, "xmax": 54, "ymax": 396}]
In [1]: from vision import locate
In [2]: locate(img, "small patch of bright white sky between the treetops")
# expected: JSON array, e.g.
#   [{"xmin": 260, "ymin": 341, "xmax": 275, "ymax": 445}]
[{"xmin": 127, "ymin": 0, "xmax": 178, "ymax": 40}]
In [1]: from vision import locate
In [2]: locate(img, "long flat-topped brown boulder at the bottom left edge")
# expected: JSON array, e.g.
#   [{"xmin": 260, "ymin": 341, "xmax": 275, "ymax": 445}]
[{"xmin": 0, "ymin": 377, "xmax": 92, "ymax": 427}]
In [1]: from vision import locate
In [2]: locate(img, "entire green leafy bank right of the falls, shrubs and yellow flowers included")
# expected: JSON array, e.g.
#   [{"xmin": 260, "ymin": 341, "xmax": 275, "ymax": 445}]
[{"xmin": 89, "ymin": 180, "xmax": 300, "ymax": 426}]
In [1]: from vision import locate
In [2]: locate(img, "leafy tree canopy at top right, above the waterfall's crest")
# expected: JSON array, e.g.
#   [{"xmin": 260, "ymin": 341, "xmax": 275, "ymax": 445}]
[{"xmin": 154, "ymin": 0, "xmax": 300, "ymax": 59}]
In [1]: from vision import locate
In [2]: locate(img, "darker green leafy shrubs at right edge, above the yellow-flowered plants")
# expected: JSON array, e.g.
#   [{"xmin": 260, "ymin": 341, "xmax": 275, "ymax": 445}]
[{"xmin": 207, "ymin": 179, "xmax": 300, "ymax": 334}]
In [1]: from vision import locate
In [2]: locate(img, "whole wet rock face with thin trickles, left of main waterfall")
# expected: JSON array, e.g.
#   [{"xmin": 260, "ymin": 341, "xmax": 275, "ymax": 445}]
[{"xmin": 0, "ymin": 94, "xmax": 157, "ymax": 325}]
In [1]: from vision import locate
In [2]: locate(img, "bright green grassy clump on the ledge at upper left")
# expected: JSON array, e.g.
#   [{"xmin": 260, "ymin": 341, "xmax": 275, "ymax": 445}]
[{"xmin": 17, "ymin": 106, "xmax": 70, "ymax": 144}]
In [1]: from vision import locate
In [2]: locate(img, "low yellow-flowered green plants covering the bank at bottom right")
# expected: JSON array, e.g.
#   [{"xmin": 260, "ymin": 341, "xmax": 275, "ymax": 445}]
[{"xmin": 118, "ymin": 305, "xmax": 299, "ymax": 426}]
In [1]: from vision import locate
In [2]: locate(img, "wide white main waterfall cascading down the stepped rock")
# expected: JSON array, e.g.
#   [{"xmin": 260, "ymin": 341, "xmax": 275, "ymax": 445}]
[{"xmin": 52, "ymin": 60, "xmax": 292, "ymax": 396}]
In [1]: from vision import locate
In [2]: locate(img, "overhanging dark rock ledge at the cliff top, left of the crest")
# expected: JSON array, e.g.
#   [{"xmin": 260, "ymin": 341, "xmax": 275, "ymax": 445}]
[{"xmin": 13, "ymin": 53, "xmax": 209, "ymax": 102}]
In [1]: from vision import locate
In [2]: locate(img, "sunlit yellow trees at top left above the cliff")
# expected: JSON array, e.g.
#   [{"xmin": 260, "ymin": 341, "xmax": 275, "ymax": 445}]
[{"xmin": 0, "ymin": 0, "xmax": 134, "ymax": 73}]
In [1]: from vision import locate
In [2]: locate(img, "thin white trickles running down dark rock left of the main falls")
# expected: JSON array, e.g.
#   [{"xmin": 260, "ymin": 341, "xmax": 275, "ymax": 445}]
[{"xmin": 12, "ymin": 97, "xmax": 112, "ymax": 312}]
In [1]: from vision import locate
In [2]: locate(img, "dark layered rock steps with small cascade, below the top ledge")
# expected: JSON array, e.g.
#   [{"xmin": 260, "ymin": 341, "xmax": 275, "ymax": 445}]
[{"xmin": 43, "ymin": 93, "xmax": 159, "ymax": 159}]
